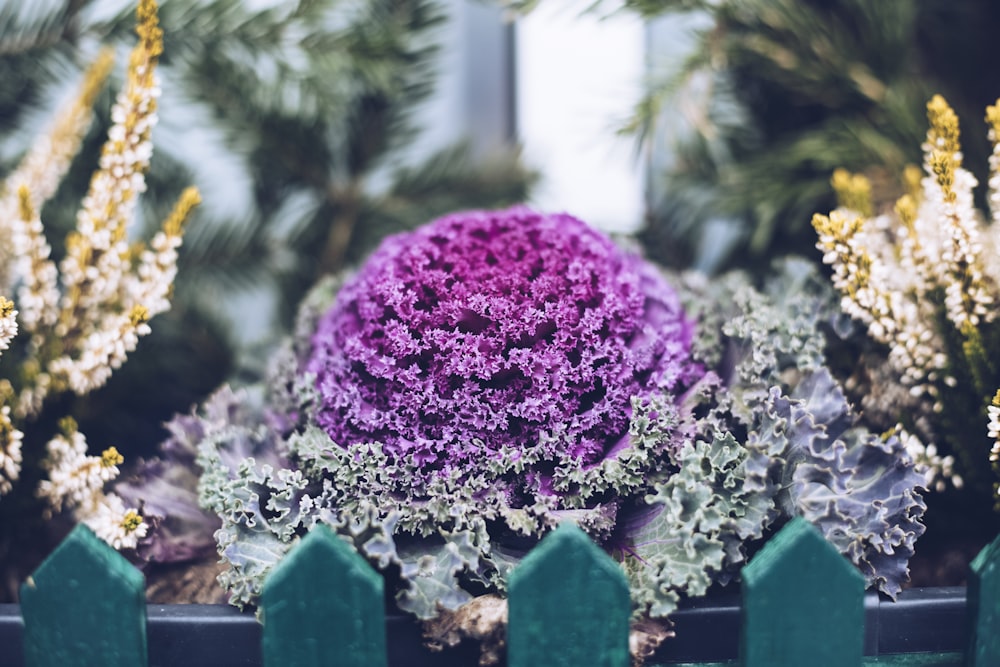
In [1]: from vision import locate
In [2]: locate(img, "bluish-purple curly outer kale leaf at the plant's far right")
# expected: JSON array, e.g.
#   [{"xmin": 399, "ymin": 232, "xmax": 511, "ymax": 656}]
[{"xmin": 747, "ymin": 369, "xmax": 926, "ymax": 598}]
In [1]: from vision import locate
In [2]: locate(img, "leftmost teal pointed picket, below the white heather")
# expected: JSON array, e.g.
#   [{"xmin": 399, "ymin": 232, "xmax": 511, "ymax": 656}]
[{"xmin": 21, "ymin": 524, "xmax": 147, "ymax": 667}]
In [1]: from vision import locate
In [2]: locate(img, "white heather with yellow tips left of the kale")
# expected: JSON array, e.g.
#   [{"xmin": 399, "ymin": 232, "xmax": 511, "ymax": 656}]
[{"xmin": 0, "ymin": 0, "xmax": 198, "ymax": 548}]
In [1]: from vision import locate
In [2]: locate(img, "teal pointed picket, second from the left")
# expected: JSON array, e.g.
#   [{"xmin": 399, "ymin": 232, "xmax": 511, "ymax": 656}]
[{"xmin": 260, "ymin": 525, "xmax": 387, "ymax": 667}]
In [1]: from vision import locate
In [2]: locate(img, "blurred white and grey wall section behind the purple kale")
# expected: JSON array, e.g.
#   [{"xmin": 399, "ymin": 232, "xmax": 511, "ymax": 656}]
[{"xmin": 390, "ymin": 0, "xmax": 646, "ymax": 233}]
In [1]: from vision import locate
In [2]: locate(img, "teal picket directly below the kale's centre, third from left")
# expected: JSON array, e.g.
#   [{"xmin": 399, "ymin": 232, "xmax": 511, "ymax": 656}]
[{"xmin": 507, "ymin": 523, "xmax": 631, "ymax": 667}]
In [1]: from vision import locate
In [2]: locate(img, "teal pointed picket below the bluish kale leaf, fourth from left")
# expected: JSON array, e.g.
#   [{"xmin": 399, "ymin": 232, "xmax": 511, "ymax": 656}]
[{"xmin": 740, "ymin": 517, "xmax": 865, "ymax": 667}]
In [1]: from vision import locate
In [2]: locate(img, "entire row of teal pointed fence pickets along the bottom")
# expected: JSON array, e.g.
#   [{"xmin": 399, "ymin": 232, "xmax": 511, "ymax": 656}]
[{"xmin": 0, "ymin": 519, "xmax": 1000, "ymax": 667}]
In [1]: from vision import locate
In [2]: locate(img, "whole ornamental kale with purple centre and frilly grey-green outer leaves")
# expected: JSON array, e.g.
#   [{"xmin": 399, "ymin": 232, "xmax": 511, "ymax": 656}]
[{"xmin": 147, "ymin": 208, "xmax": 924, "ymax": 656}]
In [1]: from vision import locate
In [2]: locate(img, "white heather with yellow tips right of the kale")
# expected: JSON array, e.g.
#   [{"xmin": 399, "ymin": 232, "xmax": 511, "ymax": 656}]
[{"xmin": 813, "ymin": 96, "xmax": 1000, "ymax": 500}]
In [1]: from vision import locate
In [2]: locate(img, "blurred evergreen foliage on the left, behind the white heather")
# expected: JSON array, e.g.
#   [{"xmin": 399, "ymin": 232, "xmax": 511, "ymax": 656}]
[{"xmin": 0, "ymin": 0, "xmax": 534, "ymax": 457}]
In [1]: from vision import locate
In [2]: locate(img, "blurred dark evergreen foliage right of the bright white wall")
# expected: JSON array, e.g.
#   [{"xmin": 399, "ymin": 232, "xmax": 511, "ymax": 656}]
[{"xmin": 597, "ymin": 0, "xmax": 1000, "ymax": 272}]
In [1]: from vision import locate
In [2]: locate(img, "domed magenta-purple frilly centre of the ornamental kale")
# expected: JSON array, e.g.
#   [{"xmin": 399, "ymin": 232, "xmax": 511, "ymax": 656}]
[{"xmin": 306, "ymin": 207, "xmax": 701, "ymax": 474}]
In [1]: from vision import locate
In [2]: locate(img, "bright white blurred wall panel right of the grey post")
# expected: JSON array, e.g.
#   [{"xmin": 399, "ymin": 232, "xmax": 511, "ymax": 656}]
[{"xmin": 516, "ymin": 0, "xmax": 645, "ymax": 233}]
